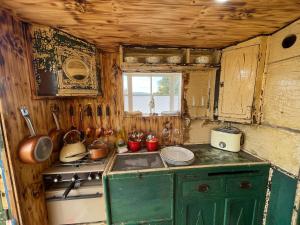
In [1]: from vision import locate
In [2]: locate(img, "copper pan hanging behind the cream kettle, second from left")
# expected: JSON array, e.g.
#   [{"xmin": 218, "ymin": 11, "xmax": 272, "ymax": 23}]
[{"xmin": 49, "ymin": 106, "xmax": 64, "ymax": 152}]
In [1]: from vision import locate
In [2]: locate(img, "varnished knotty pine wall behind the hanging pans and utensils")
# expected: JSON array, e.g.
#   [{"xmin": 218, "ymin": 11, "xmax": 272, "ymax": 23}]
[{"xmin": 0, "ymin": 11, "xmax": 182, "ymax": 225}]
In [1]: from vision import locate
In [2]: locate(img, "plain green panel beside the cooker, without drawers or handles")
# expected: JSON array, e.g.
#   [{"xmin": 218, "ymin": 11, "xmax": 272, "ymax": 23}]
[{"xmin": 108, "ymin": 172, "xmax": 174, "ymax": 224}]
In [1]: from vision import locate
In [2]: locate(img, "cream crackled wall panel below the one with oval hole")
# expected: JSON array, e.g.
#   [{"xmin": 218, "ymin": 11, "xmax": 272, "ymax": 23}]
[{"xmin": 263, "ymin": 57, "xmax": 300, "ymax": 130}]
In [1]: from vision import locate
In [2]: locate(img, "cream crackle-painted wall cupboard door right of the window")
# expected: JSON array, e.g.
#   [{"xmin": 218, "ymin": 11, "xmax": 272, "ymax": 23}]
[{"xmin": 218, "ymin": 37, "xmax": 267, "ymax": 123}]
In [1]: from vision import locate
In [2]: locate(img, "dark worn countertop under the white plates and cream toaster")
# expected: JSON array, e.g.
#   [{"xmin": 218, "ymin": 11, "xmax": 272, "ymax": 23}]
[{"xmin": 106, "ymin": 144, "xmax": 269, "ymax": 174}]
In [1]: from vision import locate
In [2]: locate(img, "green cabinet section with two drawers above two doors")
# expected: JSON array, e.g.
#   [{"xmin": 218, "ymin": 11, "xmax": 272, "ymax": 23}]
[{"xmin": 175, "ymin": 165, "xmax": 269, "ymax": 225}]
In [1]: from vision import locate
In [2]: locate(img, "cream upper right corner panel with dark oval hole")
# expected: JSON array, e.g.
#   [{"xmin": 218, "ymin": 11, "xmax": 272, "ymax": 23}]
[{"xmin": 268, "ymin": 21, "xmax": 300, "ymax": 63}]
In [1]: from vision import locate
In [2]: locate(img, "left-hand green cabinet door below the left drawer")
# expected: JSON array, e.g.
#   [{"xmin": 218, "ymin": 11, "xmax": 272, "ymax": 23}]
[{"xmin": 176, "ymin": 197, "xmax": 223, "ymax": 225}]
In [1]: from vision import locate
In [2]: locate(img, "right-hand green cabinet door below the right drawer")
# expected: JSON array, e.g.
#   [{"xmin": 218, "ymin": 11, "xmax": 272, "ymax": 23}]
[{"xmin": 224, "ymin": 197, "xmax": 259, "ymax": 225}]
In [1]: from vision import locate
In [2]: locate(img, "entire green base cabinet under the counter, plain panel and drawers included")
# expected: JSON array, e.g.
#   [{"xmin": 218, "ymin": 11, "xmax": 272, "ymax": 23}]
[{"xmin": 103, "ymin": 164, "xmax": 269, "ymax": 225}]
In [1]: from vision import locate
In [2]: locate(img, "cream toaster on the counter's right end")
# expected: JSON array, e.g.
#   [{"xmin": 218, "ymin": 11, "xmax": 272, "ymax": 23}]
[{"xmin": 210, "ymin": 127, "xmax": 243, "ymax": 152}]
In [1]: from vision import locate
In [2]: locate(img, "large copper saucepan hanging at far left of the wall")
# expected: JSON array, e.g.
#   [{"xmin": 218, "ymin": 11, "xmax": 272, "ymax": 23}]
[{"xmin": 19, "ymin": 107, "xmax": 53, "ymax": 164}]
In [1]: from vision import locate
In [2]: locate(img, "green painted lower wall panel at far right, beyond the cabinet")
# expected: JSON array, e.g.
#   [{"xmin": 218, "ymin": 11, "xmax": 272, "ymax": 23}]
[{"xmin": 267, "ymin": 169, "xmax": 297, "ymax": 225}]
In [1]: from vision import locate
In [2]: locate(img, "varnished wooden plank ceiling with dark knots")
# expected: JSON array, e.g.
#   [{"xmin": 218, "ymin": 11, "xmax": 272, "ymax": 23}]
[{"xmin": 0, "ymin": 0, "xmax": 300, "ymax": 49}]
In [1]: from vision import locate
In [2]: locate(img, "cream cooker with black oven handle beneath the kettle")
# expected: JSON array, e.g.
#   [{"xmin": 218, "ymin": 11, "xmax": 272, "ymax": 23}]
[{"xmin": 43, "ymin": 157, "xmax": 108, "ymax": 225}]
